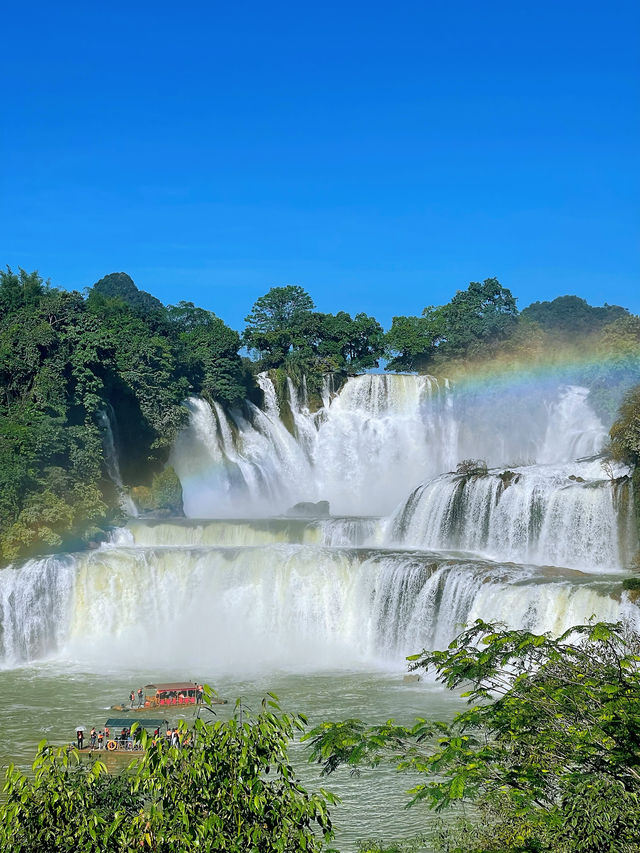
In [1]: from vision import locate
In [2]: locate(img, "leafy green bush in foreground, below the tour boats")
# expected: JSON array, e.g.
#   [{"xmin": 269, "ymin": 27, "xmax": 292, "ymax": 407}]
[{"xmin": 0, "ymin": 696, "xmax": 336, "ymax": 853}]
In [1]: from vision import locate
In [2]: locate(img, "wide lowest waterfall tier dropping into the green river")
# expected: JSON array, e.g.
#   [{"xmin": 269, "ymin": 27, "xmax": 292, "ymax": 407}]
[{"xmin": 1, "ymin": 544, "xmax": 623, "ymax": 671}]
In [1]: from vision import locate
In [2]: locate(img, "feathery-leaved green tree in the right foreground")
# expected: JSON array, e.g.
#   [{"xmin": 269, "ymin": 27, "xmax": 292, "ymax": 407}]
[{"xmin": 307, "ymin": 620, "xmax": 640, "ymax": 853}]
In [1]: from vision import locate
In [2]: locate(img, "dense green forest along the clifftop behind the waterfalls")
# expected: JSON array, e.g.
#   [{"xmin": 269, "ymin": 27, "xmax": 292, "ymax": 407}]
[{"xmin": 0, "ymin": 268, "xmax": 640, "ymax": 563}]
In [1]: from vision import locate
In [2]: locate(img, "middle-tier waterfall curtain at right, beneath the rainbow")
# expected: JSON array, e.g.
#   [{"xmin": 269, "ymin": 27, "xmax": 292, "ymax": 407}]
[{"xmin": 388, "ymin": 461, "xmax": 634, "ymax": 571}]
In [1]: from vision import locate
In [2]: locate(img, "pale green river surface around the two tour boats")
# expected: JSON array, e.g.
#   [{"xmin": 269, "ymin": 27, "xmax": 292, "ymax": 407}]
[{"xmin": 0, "ymin": 660, "xmax": 461, "ymax": 853}]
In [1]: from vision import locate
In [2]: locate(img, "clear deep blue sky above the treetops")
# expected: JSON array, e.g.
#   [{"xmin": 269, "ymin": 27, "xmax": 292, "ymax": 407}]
[{"xmin": 0, "ymin": 0, "xmax": 640, "ymax": 327}]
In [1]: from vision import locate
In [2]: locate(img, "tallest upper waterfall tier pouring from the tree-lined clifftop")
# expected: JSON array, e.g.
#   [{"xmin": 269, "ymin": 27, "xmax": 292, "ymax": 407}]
[{"xmin": 171, "ymin": 373, "xmax": 606, "ymax": 517}]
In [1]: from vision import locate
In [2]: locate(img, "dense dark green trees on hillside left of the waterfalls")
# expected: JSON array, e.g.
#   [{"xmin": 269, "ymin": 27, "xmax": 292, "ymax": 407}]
[{"xmin": 0, "ymin": 262, "xmax": 252, "ymax": 562}]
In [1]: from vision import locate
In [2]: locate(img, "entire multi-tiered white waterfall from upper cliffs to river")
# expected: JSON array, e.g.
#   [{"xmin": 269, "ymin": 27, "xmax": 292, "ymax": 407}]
[{"xmin": 0, "ymin": 374, "xmax": 637, "ymax": 672}]
